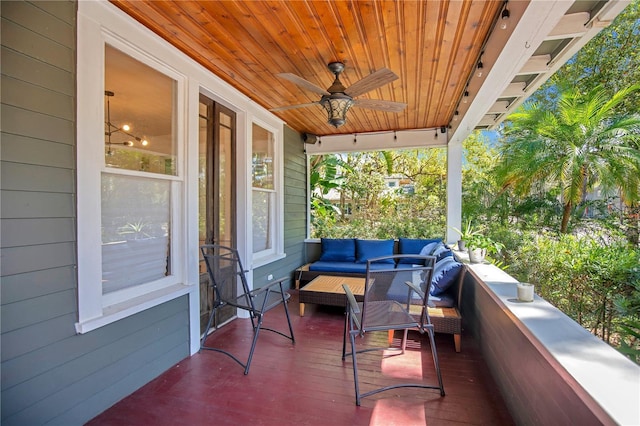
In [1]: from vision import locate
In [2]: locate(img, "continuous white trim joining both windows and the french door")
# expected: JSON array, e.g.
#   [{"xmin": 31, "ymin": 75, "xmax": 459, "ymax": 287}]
[{"xmin": 76, "ymin": 1, "xmax": 285, "ymax": 346}]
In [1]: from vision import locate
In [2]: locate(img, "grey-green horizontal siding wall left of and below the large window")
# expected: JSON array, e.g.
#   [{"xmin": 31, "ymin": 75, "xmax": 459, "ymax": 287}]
[{"xmin": 0, "ymin": 1, "xmax": 189, "ymax": 426}]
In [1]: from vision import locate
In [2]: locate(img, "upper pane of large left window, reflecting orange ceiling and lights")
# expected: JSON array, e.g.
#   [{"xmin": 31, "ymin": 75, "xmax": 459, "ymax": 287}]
[{"xmin": 104, "ymin": 45, "xmax": 176, "ymax": 175}]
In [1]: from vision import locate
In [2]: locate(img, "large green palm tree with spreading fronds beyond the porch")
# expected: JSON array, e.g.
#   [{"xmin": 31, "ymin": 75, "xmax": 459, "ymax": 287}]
[{"xmin": 496, "ymin": 84, "xmax": 640, "ymax": 233}]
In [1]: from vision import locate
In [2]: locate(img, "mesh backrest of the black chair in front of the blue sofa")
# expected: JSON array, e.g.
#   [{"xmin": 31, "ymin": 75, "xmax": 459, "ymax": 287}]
[{"xmin": 361, "ymin": 255, "xmax": 436, "ymax": 327}]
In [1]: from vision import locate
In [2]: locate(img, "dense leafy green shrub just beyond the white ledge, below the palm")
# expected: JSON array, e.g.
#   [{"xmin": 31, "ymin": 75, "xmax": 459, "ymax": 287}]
[{"xmin": 510, "ymin": 233, "xmax": 640, "ymax": 342}]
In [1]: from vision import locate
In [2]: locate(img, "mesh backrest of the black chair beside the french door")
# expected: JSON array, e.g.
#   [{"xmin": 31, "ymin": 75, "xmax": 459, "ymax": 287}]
[{"xmin": 200, "ymin": 244, "xmax": 253, "ymax": 306}]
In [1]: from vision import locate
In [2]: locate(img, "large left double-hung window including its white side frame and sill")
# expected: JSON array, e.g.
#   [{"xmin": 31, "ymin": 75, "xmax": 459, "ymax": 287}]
[{"xmin": 77, "ymin": 33, "xmax": 187, "ymax": 332}]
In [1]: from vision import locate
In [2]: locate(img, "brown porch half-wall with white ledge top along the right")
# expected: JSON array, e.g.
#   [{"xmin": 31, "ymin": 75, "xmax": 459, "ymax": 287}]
[{"xmin": 463, "ymin": 264, "xmax": 640, "ymax": 425}]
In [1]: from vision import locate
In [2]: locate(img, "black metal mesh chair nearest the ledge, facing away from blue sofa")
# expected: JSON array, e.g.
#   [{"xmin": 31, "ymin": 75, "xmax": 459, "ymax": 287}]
[{"xmin": 342, "ymin": 255, "xmax": 445, "ymax": 405}]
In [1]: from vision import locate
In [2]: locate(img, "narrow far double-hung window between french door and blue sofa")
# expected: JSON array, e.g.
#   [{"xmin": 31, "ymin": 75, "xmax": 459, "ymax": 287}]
[{"xmin": 251, "ymin": 123, "xmax": 282, "ymax": 259}]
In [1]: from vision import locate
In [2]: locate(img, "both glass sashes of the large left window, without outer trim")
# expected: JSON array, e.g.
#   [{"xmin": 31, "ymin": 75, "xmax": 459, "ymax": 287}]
[{"xmin": 100, "ymin": 45, "xmax": 176, "ymax": 300}]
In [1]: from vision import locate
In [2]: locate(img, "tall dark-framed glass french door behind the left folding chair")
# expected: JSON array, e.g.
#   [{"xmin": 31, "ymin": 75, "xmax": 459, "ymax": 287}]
[{"xmin": 198, "ymin": 94, "xmax": 236, "ymax": 333}]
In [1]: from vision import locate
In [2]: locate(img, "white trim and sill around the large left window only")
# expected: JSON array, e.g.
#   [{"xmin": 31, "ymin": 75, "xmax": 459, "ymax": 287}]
[{"xmin": 76, "ymin": 5, "xmax": 191, "ymax": 333}]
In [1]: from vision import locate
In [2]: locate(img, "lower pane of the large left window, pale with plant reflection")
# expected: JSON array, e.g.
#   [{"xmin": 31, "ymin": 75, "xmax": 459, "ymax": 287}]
[{"xmin": 102, "ymin": 173, "xmax": 171, "ymax": 294}]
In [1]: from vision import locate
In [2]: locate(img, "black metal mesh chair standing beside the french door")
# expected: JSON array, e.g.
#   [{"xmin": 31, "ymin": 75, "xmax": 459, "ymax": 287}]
[{"xmin": 200, "ymin": 244, "xmax": 295, "ymax": 374}]
